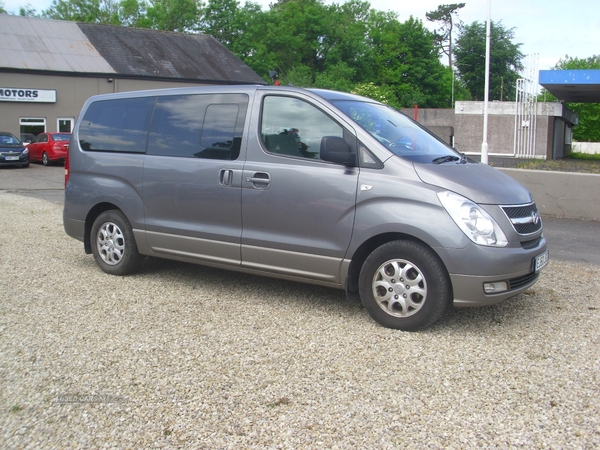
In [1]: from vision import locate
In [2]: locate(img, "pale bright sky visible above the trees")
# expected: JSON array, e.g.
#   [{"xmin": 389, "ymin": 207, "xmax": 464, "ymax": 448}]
[{"xmin": 0, "ymin": 0, "xmax": 600, "ymax": 70}]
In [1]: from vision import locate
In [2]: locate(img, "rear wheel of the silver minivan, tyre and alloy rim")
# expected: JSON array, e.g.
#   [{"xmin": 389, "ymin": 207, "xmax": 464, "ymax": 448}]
[{"xmin": 90, "ymin": 210, "xmax": 142, "ymax": 275}]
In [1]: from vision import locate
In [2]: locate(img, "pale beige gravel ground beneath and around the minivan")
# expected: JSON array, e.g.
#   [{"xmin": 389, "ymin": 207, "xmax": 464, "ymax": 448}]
[{"xmin": 0, "ymin": 192, "xmax": 600, "ymax": 449}]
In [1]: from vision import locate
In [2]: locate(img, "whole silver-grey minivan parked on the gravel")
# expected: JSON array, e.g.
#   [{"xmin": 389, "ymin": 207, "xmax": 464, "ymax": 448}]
[{"xmin": 64, "ymin": 86, "xmax": 548, "ymax": 330}]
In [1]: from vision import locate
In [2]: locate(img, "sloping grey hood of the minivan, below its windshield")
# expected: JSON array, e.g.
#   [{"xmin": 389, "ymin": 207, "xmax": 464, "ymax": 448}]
[{"xmin": 414, "ymin": 162, "xmax": 533, "ymax": 205}]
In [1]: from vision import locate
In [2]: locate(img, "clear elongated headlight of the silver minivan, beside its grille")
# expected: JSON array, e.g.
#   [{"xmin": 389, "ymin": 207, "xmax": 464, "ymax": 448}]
[{"xmin": 438, "ymin": 191, "xmax": 508, "ymax": 247}]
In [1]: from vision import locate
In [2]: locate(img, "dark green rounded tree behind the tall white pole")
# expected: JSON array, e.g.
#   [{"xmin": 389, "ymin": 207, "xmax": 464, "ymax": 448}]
[{"xmin": 454, "ymin": 21, "xmax": 524, "ymax": 101}]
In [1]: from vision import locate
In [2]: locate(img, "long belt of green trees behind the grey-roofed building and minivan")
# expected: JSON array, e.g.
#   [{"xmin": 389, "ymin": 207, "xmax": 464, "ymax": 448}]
[{"xmin": 29, "ymin": 0, "xmax": 452, "ymax": 107}]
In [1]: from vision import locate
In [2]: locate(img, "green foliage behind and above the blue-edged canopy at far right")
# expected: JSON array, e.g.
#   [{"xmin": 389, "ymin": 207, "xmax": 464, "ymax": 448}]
[{"xmin": 540, "ymin": 55, "xmax": 600, "ymax": 142}]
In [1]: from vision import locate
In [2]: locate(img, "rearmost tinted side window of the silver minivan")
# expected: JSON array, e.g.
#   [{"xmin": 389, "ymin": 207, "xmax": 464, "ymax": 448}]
[{"xmin": 79, "ymin": 97, "xmax": 156, "ymax": 153}]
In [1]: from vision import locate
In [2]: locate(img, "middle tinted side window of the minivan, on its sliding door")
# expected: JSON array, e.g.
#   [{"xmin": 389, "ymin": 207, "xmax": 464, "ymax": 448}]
[{"xmin": 148, "ymin": 94, "xmax": 248, "ymax": 160}]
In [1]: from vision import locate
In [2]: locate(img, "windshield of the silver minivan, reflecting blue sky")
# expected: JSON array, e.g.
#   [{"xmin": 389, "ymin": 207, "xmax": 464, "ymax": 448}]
[{"xmin": 332, "ymin": 100, "xmax": 466, "ymax": 164}]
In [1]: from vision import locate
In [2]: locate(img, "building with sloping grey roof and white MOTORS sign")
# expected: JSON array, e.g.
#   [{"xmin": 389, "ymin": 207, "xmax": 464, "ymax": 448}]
[{"xmin": 0, "ymin": 14, "xmax": 266, "ymax": 135}]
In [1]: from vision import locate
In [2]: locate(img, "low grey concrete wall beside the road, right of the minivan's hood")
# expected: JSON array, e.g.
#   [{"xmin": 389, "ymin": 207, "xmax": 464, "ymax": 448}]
[{"xmin": 498, "ymin": 168, "xmax": 600, "ymax": 220}]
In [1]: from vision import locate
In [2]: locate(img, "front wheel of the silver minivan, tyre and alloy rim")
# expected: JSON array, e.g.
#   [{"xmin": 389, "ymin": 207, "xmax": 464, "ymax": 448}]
[{"xmin": 359, "ymin": 241, "xmax": 452, "ymax": 331}]
